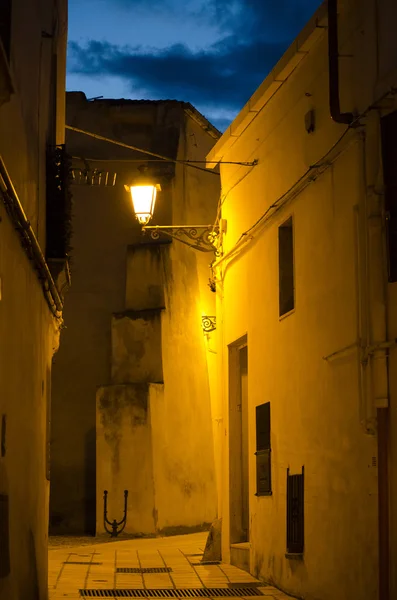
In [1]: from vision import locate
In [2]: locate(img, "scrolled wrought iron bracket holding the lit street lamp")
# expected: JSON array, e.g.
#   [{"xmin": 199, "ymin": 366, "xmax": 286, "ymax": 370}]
[{"xmin": 142, "ymin": 225, "xmax": 222, "ymax": 256}]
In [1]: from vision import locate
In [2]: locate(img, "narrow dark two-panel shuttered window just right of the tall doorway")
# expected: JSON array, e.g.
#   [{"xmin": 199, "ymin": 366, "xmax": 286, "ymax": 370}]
[{"xmin": 255, "ymin": 402, "xmax": 272, "ymax": 496}]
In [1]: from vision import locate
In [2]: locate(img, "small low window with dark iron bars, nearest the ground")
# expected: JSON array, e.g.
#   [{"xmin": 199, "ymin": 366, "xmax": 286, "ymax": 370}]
[{"xmin": 287, "ymin": 467, "xmax": 304, "ymax": 554}]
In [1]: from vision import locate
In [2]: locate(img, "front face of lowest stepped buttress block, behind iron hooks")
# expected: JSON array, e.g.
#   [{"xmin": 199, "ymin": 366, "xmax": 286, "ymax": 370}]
[{"xmin": 96, "ymin": 383, "xmax": 155, "ymax": 534}]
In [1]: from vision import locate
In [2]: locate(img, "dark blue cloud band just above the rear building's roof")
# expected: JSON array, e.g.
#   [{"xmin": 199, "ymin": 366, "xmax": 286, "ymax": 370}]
[{"xmin": 69, "ymin": 37, "xmax": 283, "ymax": 110}]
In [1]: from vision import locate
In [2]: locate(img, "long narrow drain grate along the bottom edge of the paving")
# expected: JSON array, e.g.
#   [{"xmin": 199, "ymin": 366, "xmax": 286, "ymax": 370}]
[{"xmin": 79, "ymin": 587, "xmax": 263, "ymax": 598}]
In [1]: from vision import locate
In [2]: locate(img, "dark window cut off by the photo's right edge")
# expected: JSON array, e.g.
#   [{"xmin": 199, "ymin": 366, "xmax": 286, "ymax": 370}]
[{"xmin": 381, "ymin": 111, "xmax": 397, "ymax": 283}]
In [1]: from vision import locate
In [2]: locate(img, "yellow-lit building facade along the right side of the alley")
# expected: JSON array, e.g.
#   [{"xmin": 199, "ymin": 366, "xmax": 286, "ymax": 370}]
[{"xmin": 208, "ymin": 0, "xmax": 397, "ymax": 600}]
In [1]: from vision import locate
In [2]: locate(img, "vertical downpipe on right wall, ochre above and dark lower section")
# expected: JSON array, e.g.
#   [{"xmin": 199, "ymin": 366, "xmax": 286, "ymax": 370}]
[{"xmin": 359, "ymin": 127, "xmax": 388, "ymax": 600}]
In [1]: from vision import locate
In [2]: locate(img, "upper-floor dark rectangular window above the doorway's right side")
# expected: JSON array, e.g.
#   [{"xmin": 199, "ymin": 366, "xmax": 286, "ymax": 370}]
[{"xmin": 278, "ymin": 217, "xmax": 295, "ymax": 317}]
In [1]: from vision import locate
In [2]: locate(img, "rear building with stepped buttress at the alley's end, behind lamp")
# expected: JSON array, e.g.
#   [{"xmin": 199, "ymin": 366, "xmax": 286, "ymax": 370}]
[{"xmin": 50, "ymin": 93, "xmax": 219, "ymax": 535}]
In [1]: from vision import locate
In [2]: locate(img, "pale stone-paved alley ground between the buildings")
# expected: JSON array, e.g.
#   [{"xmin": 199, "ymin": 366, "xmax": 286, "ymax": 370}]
[{"xmin": 48, "ymin": 533, "xmax": 291, "ymax": 600}]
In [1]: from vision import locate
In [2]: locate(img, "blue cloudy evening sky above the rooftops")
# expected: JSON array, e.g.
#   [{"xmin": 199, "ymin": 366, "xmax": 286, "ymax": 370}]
[{"xmin": 67, "ymin": 0, "xmax": 321, "ymax": 131}]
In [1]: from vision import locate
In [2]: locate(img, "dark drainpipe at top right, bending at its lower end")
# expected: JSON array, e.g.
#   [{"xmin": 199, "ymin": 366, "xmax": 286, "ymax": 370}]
[{"xmin": 328, "ymin": 0, "xmax": 354, "ymax": 125}]
